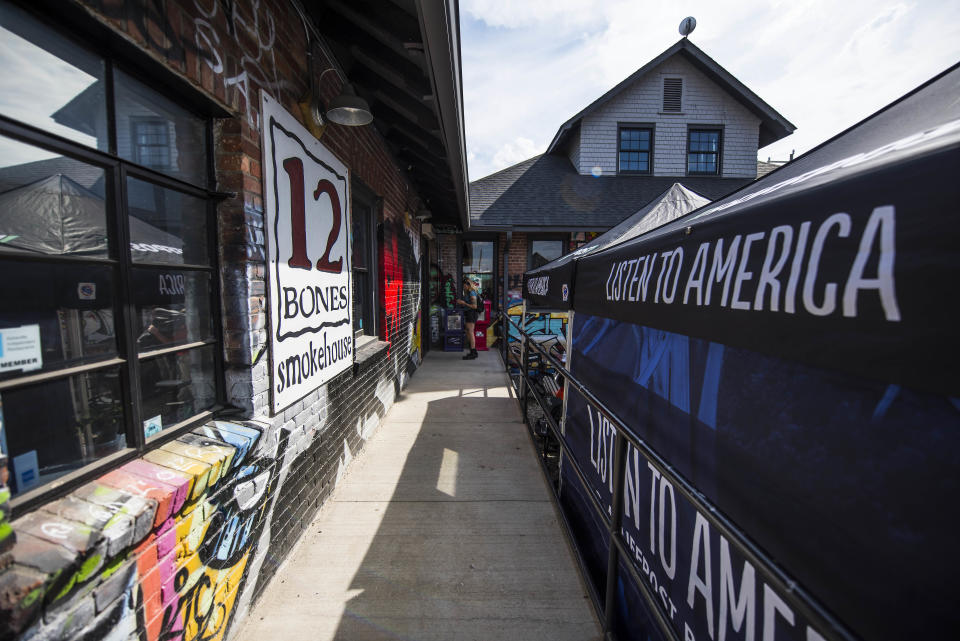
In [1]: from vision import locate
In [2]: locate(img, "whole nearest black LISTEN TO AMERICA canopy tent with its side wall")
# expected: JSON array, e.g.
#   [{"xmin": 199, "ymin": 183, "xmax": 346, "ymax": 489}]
[{"xmin": 524, "ymin": 65, "xmax": 960, "ymax": 640}]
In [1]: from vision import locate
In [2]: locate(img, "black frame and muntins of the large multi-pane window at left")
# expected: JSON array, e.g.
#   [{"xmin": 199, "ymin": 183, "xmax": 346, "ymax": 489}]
[{"xmin": 0, "ymin": 8, "xmax": 228, "ymax": 512}]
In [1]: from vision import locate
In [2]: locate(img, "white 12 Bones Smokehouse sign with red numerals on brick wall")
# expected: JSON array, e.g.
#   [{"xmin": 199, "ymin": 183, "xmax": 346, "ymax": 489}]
[{"xmin": 262, "ymin": 93, "xmax": 353, "ymax": 413}]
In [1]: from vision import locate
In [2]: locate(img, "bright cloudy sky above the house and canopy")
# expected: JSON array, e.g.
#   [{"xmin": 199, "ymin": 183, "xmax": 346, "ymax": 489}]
[{"xmin": 460, "ymin": 0, "xmax": 960, "ymax": 180}]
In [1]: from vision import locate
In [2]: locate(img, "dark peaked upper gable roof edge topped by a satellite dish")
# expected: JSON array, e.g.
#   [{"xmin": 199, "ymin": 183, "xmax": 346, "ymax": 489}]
[{"xmin": 547, "ymin": 38, "xmax": 796, "ymax": 154}]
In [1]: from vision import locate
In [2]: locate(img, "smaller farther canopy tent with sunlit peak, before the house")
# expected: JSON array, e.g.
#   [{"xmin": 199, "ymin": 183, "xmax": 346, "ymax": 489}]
[{"xmin": 523, "ymin": 183, "xmax": 710, "ymax": 310}]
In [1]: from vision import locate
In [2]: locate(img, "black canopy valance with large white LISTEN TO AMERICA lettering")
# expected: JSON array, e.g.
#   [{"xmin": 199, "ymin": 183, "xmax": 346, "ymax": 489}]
[{"xmin": 576, "ymin": 151, "xmax": 960, "ymax": 395}]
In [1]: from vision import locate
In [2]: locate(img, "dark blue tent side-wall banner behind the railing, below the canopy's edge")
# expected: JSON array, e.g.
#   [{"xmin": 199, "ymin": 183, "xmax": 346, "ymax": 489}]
[{"xmin": 561, "ymin": 312, "xmax": 960, "ymax": 641}]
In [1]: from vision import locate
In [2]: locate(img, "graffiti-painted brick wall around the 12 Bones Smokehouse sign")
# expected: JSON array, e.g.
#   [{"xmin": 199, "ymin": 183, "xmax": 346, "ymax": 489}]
[{"xmin": 0, "ymin": 0, "xmax": 423, "ymax": 641}]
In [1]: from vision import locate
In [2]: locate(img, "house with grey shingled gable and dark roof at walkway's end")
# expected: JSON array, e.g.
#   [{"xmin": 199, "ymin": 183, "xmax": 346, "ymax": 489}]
[{"xmin": 438, "ymin": 38, "xmax": 795, "ymax": 307}]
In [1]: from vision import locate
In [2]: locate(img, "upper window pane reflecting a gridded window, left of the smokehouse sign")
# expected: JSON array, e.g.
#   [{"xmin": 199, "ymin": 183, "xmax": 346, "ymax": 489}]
[{"xmin": 116, "ymin": 72, "xmax": 207, "ymax": 185}]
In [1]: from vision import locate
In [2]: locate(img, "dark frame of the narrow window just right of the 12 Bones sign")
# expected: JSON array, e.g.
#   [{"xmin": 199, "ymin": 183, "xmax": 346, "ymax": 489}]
[{"xmin": 350, "ymin": 178, "xmax": 383, "ymax": 340}]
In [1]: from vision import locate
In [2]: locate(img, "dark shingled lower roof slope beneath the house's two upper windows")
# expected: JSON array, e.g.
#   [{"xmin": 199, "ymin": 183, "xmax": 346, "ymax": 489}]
[{"xmin": 470, "ymin": 154, "xmax": 753, "ymax": 231}]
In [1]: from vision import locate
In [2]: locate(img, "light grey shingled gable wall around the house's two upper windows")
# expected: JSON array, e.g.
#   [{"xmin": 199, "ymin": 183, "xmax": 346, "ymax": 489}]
[{"xmin": 570, "ymin": 56, "xmax": 760, "ymax": 178}]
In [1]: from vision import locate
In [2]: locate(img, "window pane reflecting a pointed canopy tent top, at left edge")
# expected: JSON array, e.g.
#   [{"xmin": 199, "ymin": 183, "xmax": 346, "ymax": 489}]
[{"xmin": 0, "ymin": 136, "xmax": 108, "ymax": 258}]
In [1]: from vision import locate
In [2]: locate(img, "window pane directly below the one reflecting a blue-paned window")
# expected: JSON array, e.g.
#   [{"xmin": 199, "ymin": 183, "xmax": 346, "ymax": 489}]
[{"xmin": 127, "ymin": 178, "xmax": 210, "ymax": 265}]
